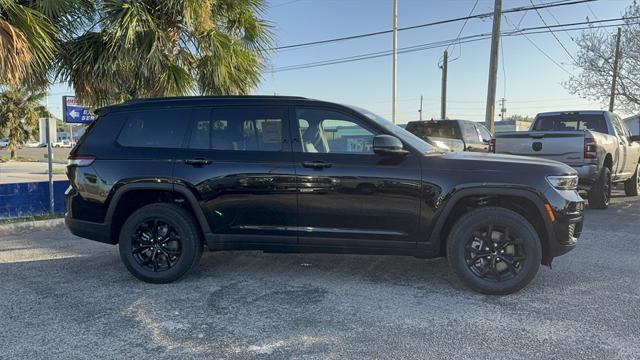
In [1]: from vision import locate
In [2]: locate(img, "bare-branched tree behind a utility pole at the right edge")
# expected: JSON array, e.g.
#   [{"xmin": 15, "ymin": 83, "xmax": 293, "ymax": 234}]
[{"xmin": 564, "ymin": 1, "xmax": 640, "ymax": 112}]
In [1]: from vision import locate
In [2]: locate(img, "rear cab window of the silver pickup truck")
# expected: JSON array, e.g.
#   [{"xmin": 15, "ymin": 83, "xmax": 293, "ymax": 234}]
[{"xmin": 533, "ymin": 114, "xmax": 608, "ymax": 134}]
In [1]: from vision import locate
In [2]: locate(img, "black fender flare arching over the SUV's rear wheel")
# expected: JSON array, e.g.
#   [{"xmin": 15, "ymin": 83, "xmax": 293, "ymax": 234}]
[{"xmin": 105, "ymin": 182, "xmax": 211, "ymax": 235}]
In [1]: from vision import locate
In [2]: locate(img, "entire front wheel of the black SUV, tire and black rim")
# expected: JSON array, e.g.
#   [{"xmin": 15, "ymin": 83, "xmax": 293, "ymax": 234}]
[{"xmin": 447, "ymin": 207, "xmax": 542, "ymax": 295}]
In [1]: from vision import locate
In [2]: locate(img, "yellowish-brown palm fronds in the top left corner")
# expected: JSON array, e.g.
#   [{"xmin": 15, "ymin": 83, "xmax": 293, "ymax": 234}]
[{"xmin": 0, "ymin": 0, "xmax": 95, "ymax": 86}]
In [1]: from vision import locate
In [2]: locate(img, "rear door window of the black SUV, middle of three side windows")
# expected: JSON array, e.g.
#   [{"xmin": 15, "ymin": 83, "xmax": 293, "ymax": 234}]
[{"xmin": 189, "ymin": 108, "xmax": 286, "ymax": 151}]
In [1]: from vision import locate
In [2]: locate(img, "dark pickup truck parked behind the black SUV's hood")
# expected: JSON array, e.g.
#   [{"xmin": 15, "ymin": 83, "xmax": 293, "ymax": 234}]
[{"xmin": 406, "ymin": 120, "xmax": 493, "ymax": 152}]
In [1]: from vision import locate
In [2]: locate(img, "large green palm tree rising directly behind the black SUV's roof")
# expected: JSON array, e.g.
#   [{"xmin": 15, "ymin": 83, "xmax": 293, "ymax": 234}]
[{"xmin": 55, "ymin": 0, "xmax": 271, "ymax": 105}]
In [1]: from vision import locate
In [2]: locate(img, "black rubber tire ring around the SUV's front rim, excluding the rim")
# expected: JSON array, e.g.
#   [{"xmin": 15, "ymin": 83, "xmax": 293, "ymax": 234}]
[{"xmin": 447, "ymin": 208, "xmax": 542, "ymax": 295}]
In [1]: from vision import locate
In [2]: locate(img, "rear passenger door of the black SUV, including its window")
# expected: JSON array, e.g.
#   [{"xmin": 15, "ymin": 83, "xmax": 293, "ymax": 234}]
[{"xmin": 175, "ymin": 106, "xmax": 297, "ymax": 243}]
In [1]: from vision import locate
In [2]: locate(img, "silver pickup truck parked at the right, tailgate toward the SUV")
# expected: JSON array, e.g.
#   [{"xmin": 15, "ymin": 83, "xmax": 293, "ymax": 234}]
[{"xmin": 495, "ymin": 111, "xmax": 640, "ymax": 209}]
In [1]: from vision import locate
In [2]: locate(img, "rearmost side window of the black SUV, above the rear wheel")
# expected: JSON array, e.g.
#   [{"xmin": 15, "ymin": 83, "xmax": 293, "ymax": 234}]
[{"xmin": 118, "ymin": 109, "xmax": 190, "ymax": 148}]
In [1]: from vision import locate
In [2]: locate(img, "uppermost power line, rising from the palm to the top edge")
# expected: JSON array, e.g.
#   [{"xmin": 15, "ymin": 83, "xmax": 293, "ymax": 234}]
[{"xmin": 268, "ymin": 0, "xmax": 598, "ymax": 51}]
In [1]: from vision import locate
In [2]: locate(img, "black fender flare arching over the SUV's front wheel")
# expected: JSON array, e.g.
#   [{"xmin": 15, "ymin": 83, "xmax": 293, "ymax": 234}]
[{"xmin": 429, "ymin": 185, "xmax": 555, "ymax": 258}]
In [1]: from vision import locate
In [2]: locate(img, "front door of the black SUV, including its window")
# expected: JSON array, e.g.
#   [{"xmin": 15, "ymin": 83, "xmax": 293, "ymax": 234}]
[{"xmin": 291, "ymin": 107, "xmax": 421, "ymax": 247}]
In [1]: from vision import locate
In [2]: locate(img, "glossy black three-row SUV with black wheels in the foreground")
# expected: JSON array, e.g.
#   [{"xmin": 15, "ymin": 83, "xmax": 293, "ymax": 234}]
[{"xmin": 66, "ymin": 96, "xmax": 583, "ymax": 294}]
